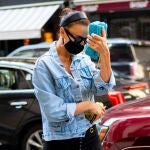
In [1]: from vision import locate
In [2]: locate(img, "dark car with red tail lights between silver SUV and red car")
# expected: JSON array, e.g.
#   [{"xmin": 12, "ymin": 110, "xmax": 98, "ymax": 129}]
[{"xmin": 95, "ymin": 70, "xmax": 150, "ymax": 109}]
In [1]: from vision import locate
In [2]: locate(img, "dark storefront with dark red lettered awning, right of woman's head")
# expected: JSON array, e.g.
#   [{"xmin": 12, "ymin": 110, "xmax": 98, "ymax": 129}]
[{"xmin": 75, "ymin": 0, "xmax": 150, "ymax": 40}]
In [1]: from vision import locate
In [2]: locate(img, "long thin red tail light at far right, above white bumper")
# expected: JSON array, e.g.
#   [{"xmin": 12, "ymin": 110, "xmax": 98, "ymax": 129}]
[{"xmin": 122, "ymin": 82, "xmax": 148, "ymax": 90}]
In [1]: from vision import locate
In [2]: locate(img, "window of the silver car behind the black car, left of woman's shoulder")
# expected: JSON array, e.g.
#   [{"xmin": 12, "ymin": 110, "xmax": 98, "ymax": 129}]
[{"xmin": 13, "ymin": 48, "xmax": 49, "ymax": 57}]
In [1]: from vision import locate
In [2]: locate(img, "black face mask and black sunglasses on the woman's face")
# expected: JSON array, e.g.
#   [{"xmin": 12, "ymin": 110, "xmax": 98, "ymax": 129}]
[{"xmin": 64, "ymin": 29, "xmax": 86, "ymax": 54}]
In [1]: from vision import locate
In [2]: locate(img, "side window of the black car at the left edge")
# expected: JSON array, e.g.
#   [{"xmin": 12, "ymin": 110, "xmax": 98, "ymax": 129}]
[{"xmin": 0, "ymin": 68, "xmax": 33, "ymax": 90}]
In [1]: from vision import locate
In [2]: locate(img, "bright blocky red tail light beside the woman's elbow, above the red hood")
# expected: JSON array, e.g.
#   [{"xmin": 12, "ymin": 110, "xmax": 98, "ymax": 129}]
[{"xmin": 107, "ymin": 91, "xmax": 125, "ymax": 106}]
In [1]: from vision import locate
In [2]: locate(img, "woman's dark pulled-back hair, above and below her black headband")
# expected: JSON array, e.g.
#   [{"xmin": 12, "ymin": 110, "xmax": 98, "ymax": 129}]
[{"xmin": 60, "ymin": 8, "xmax": 90, "ymax": 28}]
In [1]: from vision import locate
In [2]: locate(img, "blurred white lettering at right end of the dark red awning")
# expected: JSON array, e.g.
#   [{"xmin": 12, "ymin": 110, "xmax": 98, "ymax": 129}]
[{"xmin": 130, "ymin": 0, "xmax": 149, "ymax": 8}]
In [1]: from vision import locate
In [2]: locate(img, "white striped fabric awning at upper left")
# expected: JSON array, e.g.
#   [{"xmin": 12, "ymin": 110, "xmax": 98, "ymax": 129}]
[{"xmin": 0, "ymin": 5, "xmax": 60, "ymax": 40}]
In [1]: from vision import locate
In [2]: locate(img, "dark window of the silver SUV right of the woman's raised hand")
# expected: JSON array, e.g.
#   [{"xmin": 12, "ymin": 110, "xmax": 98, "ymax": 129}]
[{"xmin": 108, "ymin": 44, "xmax": 133, "ymax": 62}]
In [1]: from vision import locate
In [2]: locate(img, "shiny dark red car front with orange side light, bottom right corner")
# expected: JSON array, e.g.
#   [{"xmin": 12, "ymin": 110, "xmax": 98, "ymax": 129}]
[{"xmin": 99, "ymin": 97, "xmax": 150, "ymax": 150}]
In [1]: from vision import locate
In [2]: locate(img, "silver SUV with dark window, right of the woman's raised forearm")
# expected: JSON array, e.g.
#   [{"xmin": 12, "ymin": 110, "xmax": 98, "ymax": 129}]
[{"xmin": 108, "ymin": 38, "xmax": 150, "ymax": 80}]
